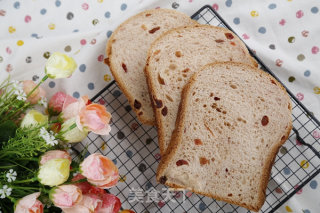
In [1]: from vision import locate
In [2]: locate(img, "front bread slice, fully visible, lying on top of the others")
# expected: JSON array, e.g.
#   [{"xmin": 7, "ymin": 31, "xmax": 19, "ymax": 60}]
[{"xmin": 157, "ymin": 62, "xmax": 292, "ymax": 211}]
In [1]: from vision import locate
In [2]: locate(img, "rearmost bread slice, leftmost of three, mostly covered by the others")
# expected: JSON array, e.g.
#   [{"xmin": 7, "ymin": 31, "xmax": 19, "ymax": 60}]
[{"xmin": 106, "ymin": 9, "xmax": 197, "ymax": 125}]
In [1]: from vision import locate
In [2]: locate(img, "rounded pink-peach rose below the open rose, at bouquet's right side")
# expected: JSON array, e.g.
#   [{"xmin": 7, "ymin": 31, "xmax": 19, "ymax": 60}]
[{"xmin": 80, "ymin": 153, "xmax": 119, "ymax": 189}]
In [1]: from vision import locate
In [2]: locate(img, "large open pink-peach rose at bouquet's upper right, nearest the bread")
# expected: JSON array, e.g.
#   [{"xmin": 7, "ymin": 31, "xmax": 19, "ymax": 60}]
[{"xmin": 62, "ymin": 96, "xmax": 111, "ymax": 135}]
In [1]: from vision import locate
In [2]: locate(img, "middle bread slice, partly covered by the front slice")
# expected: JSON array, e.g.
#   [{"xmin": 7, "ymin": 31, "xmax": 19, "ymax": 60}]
[{"xmin": 145, "ymin": 25, "xmax": 256, "ymax": 155}]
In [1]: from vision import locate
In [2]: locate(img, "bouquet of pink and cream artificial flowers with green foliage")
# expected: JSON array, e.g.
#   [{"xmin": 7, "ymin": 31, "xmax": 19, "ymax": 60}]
[{"xmin": 0, "ymin": 53, "xmax": 132, "ymax": 213}]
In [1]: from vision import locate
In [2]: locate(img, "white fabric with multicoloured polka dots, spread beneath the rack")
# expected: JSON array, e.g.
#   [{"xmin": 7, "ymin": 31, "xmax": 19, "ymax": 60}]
[{"xmin": 0, "ymin": 0, "xmax": 320, "ymax": 213}]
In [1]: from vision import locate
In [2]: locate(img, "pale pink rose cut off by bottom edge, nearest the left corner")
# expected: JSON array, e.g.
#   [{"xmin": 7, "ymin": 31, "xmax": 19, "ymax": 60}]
[{"xmin": 14, "ymin": 192, "xmax": 43, "ymax": 213}]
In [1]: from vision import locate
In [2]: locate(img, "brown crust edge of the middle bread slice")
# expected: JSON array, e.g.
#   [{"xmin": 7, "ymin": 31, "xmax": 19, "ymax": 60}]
[{"xmin": 144, "ymin": 24, "xmax": 258, "ymax": 155}]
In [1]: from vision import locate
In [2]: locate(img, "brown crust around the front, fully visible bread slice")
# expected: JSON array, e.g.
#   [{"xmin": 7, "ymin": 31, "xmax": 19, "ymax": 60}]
[{"xmin": 157, "ymin": 62, "xmax": 292, "ymax": 211}]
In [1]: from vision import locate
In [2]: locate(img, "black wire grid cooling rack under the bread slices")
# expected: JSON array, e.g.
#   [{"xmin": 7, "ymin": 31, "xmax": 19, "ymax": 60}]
[{"xmin": 73, "ymin": 6, "xmax": 320, "ymax": 213}]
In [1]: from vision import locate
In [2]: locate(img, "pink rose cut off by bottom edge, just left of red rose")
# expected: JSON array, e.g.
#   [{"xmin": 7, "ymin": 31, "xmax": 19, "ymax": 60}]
[{"xmin": 62, "ymin": 194, "xmax": 102, "ymax": 213}]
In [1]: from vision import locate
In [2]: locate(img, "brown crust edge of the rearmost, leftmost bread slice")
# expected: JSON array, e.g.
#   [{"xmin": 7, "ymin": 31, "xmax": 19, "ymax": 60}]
[{"xmin": 106, "ymin": 9, "xmax": 198, "ymax": 126}]
